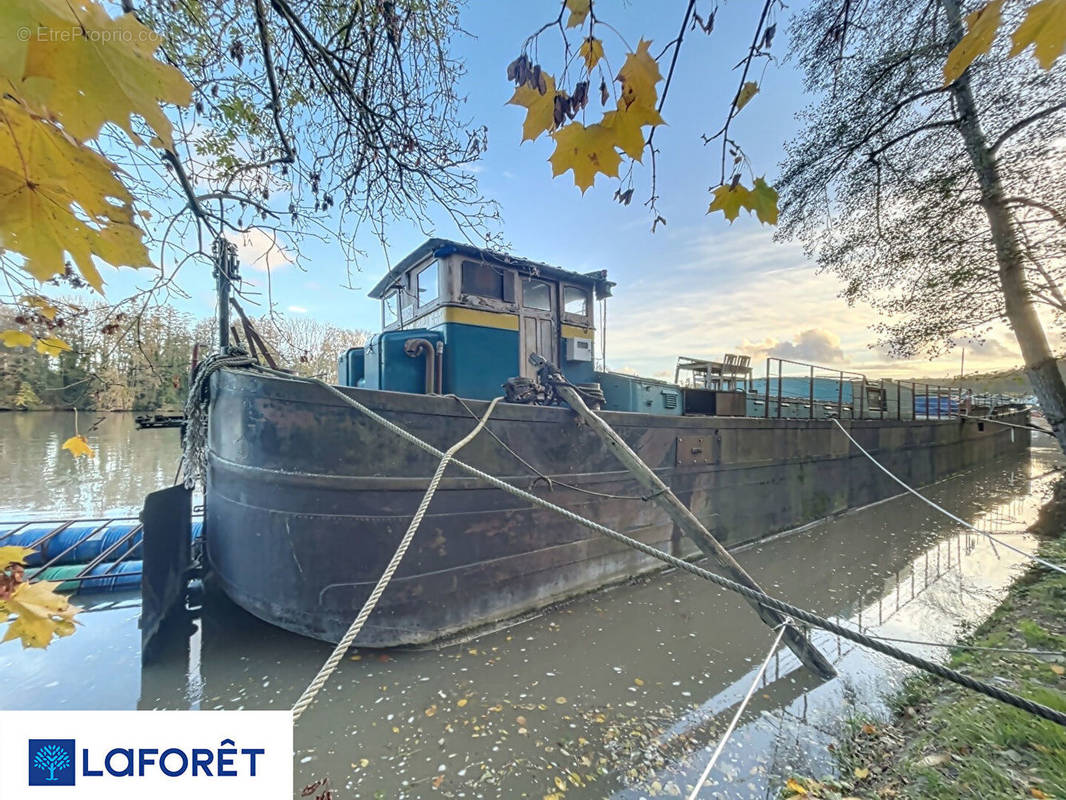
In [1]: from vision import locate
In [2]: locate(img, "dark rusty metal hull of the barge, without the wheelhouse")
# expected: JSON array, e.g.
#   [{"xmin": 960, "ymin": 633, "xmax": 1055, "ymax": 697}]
[{"xmin": 205, "ymin": 370, "xmax": 1030, "ymax": 647}]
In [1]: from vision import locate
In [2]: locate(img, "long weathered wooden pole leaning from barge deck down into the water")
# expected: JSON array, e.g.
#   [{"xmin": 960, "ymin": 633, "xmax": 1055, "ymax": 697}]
[{"xmin": 530, "ymin": 353, "xmax": 837, "ymax": 681}]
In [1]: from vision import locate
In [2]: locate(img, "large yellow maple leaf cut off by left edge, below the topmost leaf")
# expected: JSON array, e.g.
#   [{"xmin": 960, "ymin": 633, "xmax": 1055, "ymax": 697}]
[{"xmin": 0, "ymin": 99, "xmax": 150, "ymax": 291}]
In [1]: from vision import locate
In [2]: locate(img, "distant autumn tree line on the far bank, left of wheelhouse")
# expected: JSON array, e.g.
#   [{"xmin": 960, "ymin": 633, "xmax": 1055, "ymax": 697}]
[{"xmin": 0, "ymin": 304, "xmax": 367, "ymax": 411}]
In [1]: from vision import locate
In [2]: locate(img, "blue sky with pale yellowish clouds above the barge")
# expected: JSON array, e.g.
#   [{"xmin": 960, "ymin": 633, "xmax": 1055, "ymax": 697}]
[{"xmin": 95, "ymin": 0, "xmax": 1020, "ymax": 375}]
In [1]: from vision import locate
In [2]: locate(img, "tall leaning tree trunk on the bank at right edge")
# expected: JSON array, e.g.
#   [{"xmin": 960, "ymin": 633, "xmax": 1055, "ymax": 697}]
[{"xmin": 941, "ymin": 0, "xmax": 1066, "ymax": 451}]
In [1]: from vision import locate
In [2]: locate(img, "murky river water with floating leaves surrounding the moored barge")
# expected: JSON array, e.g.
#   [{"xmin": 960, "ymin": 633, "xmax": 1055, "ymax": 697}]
[{"xmin": 0, "ymin": 414, "xmax": 1064, "ymax": 800}]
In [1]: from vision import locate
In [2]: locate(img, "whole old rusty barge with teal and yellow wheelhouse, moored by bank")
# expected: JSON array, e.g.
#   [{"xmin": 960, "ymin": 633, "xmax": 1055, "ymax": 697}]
[{"xmin": 205, "ymin": 239, "xmax": 1029, "ymax": 647}]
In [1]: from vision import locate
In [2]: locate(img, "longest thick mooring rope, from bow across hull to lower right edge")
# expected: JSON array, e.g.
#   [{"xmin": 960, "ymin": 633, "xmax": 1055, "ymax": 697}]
[{"xmin": 254, "ymin": 365, "xmax": 1066, "ymax": 727}]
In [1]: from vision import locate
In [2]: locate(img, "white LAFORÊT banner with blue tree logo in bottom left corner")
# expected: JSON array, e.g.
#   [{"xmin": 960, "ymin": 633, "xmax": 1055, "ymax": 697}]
[{"xmin": 0, "ymin": 710, "xmax": 293, "ymax": 800}]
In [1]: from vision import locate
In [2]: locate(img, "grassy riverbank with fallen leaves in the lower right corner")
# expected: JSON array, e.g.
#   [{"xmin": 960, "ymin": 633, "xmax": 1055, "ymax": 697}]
[{"xmin": 782, "ymin": 509, "xmax": 1066, "ymax": 800}]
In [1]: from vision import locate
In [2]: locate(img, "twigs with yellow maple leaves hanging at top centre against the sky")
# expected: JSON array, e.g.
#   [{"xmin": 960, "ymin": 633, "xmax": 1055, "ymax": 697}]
[{"xmin": 507, "ymin": 0, "xmax": 780, "ymax": 230}]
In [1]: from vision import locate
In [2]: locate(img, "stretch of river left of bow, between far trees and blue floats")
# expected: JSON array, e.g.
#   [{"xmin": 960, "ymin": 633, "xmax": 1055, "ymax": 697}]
[{"xmin": 0, "ymin": 412, "xmax": 181, "ymax": 519}]
